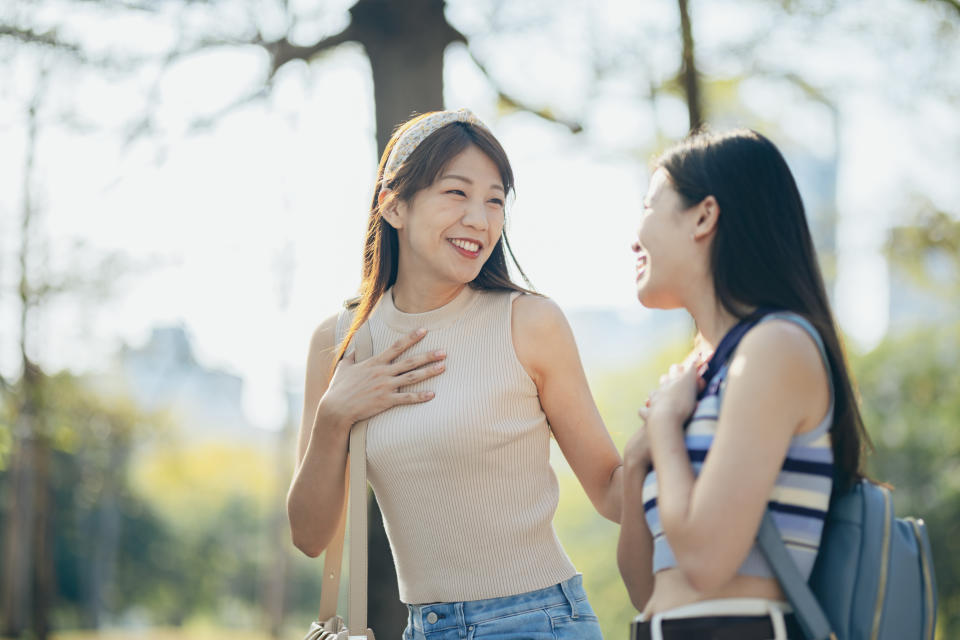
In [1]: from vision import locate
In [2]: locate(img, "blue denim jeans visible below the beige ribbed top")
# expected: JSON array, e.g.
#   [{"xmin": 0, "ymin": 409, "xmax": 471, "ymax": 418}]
[{"xmin": 407, "ymin": 574, "xmax": 587, "ymax": 632}]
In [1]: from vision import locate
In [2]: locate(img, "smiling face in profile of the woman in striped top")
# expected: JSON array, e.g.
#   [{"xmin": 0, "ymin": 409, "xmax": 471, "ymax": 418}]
[{"xmin": 632, "ymin": 169, "xmax": 701, "ymax": 309}]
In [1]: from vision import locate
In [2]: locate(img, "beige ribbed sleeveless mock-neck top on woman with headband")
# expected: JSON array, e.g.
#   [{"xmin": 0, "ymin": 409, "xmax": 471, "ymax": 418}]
[{"xmin": 340, "ymin": 287, "xmax": 576, "ymax": 604}]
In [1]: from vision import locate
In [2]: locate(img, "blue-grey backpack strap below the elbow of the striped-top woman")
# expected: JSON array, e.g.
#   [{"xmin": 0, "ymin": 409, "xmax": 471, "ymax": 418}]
[{"xmin": 757, "ymin": 509, "xmax": 837, "ymax": 640}]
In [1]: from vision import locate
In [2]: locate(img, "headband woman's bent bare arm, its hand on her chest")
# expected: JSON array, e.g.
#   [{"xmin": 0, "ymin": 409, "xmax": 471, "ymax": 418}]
[{"xmin": 287, "ymin": 316, "xmax": 445, "ymax": 557}]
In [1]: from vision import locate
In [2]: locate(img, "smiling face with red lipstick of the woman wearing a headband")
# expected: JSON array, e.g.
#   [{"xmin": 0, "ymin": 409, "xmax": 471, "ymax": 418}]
[{"xmin": 384, "ymin": 145, "xmax": 505, "ymax": 285}]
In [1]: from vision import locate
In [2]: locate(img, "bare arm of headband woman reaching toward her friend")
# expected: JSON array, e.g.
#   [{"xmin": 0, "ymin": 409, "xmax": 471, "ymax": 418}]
[{"xmin": 512, "ymin": 295, "xmax": 623, "ymax": 522}]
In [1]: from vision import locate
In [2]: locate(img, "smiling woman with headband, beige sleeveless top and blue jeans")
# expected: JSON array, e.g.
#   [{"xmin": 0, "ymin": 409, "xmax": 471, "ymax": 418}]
[{"xmin": 287, "ymin": 109, "xmax": 622, "ymax": 640}]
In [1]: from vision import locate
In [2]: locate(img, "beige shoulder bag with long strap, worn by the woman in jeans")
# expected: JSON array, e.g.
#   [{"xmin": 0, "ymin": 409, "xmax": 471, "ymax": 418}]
[{"xmin": 303, "ymin": 316, "xmax": 375, "ymax": 640}]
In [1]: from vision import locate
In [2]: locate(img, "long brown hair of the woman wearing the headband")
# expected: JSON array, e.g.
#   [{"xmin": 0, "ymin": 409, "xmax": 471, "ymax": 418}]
[{"xmin": 334, "ymin": 113, "xmax": 533, "ymax": 362}]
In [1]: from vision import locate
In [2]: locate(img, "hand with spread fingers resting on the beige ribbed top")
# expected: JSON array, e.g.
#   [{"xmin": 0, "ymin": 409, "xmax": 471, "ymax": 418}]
[{"xmin": 315, "ymin": 329, "xmax": 446, "ymax": 429}]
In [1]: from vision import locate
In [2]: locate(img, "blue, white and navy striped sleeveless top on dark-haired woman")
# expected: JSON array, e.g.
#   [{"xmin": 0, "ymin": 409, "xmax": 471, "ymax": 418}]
[{"xmin": 643, "ymin": 311, "xmax": 834, "ymax": 578}]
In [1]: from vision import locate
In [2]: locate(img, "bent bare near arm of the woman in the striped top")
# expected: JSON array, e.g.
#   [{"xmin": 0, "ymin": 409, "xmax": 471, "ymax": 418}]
[{"xmin": 647, "ymin": 320, "xmax": 829, "ymax": 592}]
